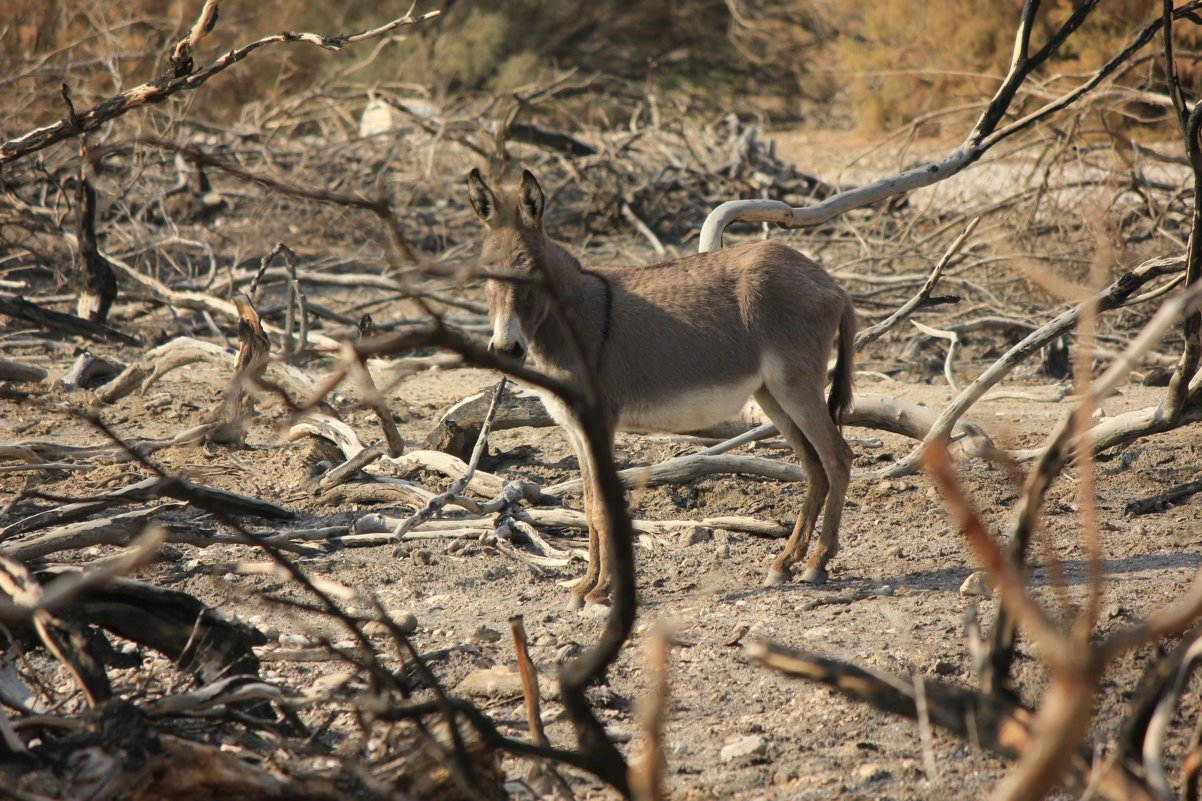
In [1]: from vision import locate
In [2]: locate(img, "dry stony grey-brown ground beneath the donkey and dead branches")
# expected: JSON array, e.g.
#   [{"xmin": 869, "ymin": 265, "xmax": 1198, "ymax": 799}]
[{"xmin": 0, "ymin": 334, "xmax": 1202, "ymax": 799}]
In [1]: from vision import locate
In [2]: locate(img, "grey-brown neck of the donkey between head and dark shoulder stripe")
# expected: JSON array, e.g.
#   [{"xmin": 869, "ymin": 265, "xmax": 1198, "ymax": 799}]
[{"xmin": 524, "ymin": 237, "xmax": 609, "ymax": 375}]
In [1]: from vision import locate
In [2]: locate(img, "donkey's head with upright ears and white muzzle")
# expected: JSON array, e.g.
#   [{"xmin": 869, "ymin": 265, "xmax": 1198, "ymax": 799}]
[{"xmin": 468, "ymin": 170, "xmax": 547, "ymax": 361}]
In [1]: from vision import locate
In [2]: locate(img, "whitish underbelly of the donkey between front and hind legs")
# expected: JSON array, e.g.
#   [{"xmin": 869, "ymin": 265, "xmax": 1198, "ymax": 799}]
[{"xmin": 618, "ymin": 374, "xmax": 762, "ymax": 433}]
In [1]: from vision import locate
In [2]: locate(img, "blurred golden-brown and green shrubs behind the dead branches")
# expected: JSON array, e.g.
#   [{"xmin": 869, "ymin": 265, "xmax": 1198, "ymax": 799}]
[{"xmin": 7, "ymin": 0, "xmax": 1202, "ymax": 134}]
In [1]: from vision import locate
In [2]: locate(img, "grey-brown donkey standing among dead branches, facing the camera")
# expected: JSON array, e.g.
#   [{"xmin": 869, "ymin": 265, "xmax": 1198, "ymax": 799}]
[{"xmin": 468, "ymin": 170, "xmax": 856, "ymax": 606}]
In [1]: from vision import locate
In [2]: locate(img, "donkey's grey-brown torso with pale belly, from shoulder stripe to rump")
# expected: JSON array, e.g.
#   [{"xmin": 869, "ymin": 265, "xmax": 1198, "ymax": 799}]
[{"xmin": 576, "ymin": 242, "xmax": 850, "ymax": 432}]
